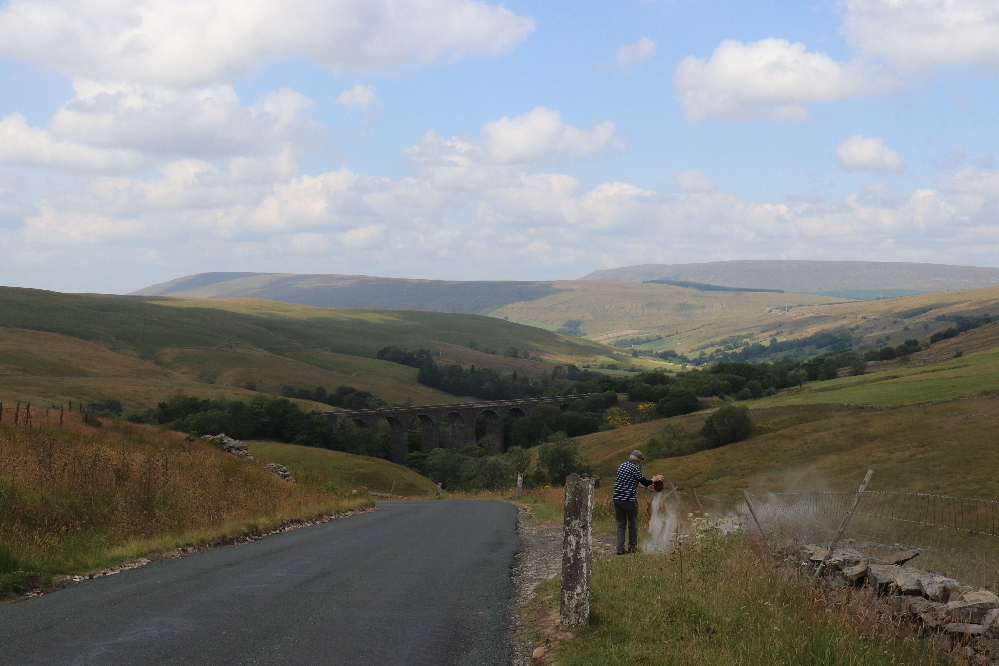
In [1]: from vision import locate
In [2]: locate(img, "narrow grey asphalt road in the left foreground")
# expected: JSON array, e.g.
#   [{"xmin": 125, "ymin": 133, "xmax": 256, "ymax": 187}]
[{"xmin": 0, "ymin": 501, "xmax": 518, "ymax": 666}]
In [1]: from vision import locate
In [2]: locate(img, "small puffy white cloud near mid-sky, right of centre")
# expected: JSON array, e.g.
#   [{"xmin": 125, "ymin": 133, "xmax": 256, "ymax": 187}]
[{"xmin": 482, "ymin": 106, "xmax": 622, "ymax": 164}]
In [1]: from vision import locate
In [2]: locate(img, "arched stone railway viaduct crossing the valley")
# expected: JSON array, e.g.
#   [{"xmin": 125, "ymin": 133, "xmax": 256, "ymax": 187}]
[{"xmin": 326, "ymin": 395, "xmax": 586, "ymax": 465}]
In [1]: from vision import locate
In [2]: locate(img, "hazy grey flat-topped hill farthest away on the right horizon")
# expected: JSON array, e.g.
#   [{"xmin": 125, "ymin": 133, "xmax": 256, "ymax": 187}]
[{"xmin": 582, "ymin": 260, "xmax": 999, "ymax": 300}]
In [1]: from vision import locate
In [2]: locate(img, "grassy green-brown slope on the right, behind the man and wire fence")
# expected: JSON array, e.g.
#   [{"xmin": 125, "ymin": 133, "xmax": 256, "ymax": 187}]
[{"xmin": 579, "ymin": 325, "xmax": 999, "ymax": 499}]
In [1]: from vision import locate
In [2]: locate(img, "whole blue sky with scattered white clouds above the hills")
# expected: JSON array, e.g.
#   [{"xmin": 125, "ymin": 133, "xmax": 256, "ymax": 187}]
[{"xmin": 0, "ymin": 0, "xmax": 999, "ymax": 293}]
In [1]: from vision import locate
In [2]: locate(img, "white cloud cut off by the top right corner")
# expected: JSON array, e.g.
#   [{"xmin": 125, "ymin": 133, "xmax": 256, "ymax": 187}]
[{"xmin": 844, "ymin": 0, "xmax": 999, "ymax": 69}]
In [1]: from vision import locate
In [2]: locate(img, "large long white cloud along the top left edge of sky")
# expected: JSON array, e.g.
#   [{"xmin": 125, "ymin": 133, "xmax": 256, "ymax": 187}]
[{"xmin": 0, "ymin": 0, "xmax": 534, "ymax": 87}]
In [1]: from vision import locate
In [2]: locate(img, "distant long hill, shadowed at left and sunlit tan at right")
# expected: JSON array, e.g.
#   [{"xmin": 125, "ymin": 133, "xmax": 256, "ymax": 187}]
[{"xmin": 133, "ymin": 273, "xmax": 852, "ymax": 342}]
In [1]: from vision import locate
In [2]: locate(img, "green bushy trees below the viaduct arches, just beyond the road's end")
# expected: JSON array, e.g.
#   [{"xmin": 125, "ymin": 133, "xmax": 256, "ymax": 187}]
[{"xmin": 406, "ymin": 432, "xmax": 590, "ymax": 491}]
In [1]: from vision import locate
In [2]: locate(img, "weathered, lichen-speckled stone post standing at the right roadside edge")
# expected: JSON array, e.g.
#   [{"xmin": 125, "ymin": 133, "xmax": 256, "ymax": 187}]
[{"xmin": 559, "ymin": 474, "xmax": 593, "ymax": 629}]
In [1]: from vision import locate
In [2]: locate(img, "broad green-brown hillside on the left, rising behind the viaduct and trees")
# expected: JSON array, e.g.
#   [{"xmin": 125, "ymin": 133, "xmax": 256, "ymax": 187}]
[{"xmin": 0, "ymin": 288, "xmax": 625, "ymax": 409}]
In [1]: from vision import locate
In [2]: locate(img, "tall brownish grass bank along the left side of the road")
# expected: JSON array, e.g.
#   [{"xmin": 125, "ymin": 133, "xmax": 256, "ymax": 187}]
[{"xmin": 0, "ymin": 418, "xmax": 370, "ymax": 596}]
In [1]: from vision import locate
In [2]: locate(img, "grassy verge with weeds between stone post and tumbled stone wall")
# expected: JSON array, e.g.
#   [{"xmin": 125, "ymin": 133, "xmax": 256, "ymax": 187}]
[{"xmin": 545, "ymin": 533, "xmax": 947, "ymax": 666}]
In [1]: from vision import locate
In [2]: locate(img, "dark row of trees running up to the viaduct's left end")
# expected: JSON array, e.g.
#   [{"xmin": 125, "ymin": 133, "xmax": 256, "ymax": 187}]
[{"xmin": 127, "ymin": 393, "xmax": 390, "ymax": 458}]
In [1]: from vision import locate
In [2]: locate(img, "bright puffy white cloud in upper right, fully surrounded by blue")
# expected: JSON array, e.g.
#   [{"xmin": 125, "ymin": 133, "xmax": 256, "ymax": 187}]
[{"xmin": 673, "ymin": 38, "xmax": 896, "ymax": 123}]
